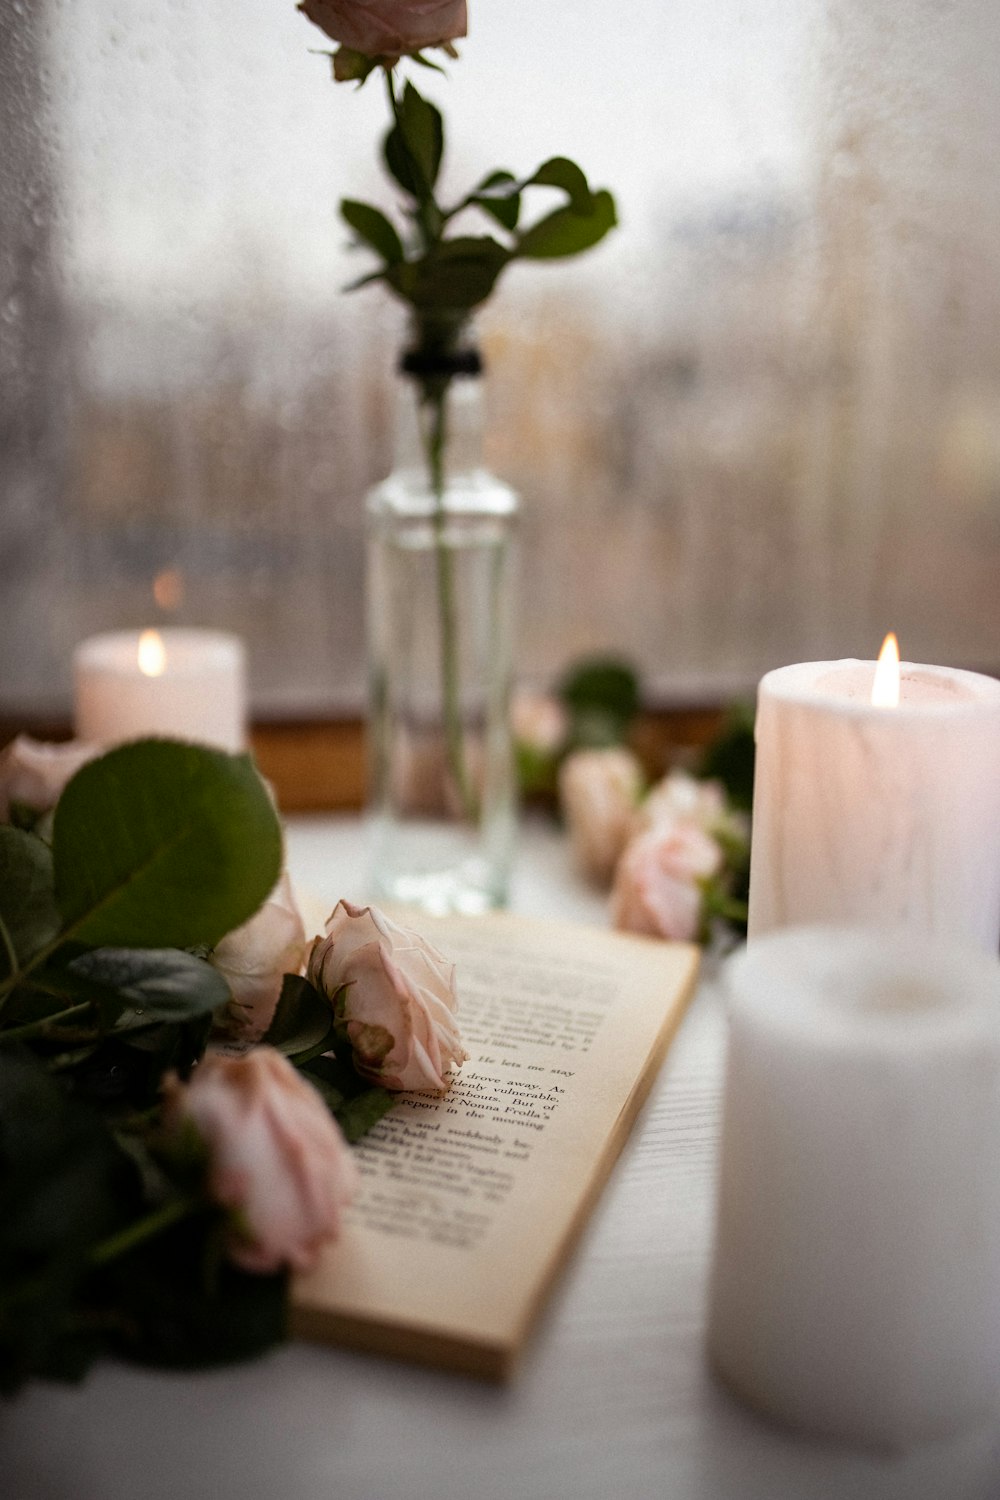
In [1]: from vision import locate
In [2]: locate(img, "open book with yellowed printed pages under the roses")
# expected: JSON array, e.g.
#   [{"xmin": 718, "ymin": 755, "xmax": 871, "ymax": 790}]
[{"xmin": 292, "ymin": 915, "xmax": 699, "ymax": 1379}]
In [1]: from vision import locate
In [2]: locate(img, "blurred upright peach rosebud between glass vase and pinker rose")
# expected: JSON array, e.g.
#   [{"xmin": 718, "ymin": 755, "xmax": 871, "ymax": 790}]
[{"xmin": 559, "ymin": 750, "xmax": 643, "ymax": 885}]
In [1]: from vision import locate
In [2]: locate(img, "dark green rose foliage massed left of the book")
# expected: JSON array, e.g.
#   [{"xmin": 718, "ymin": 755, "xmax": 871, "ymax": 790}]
[{"xmin": 0, "ymin": 740, "xmax": 305, "ymax": 1389}]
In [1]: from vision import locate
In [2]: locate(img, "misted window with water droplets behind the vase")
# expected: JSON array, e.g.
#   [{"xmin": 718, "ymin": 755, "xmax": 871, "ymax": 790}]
[{"xmin": 0, "ymin": 0, "xmax": 1000, "ymax": 717}]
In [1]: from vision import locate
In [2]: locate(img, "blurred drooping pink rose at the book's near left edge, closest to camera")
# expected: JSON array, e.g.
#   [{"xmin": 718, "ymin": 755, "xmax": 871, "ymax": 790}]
[{"xmin": 163, "ymin": 1047, "xmax": 358, "ymax": 1272}]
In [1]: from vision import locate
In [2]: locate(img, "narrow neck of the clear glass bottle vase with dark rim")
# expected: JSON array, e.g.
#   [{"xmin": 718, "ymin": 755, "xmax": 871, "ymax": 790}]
[{"xmin": 396, "ymin": 320, "xmax": 483, "ymax": 491}]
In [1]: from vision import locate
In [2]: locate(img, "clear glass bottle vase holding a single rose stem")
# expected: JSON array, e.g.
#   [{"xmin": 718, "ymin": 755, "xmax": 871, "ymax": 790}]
[{"xmin": 367, "ymin": 331, "xmax": 519, "ymax": 914}]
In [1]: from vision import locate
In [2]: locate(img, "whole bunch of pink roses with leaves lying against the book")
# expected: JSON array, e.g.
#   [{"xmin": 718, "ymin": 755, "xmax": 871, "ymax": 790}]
[{"xmin": 0, "ymin": 740, "xmax": 446, "ymax": 1391}]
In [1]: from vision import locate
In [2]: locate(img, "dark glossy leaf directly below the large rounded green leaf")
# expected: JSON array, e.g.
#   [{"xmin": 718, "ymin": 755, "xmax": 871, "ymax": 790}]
[{"xmin": 66, "ymin": 948, "xmax": 229, "ymax": 1031}]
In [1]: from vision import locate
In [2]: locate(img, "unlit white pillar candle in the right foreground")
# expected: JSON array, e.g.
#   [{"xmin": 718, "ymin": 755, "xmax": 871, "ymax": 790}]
[{"xmin": 709, "ymin": 927, "xmax": 1000, "ymax": 1448}]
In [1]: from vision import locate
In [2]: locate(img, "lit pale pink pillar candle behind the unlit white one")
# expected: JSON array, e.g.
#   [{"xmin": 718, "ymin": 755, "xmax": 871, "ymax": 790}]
[{"xmin": 750, "ymin": 662, "xmax": 1000, "ymax": 954}]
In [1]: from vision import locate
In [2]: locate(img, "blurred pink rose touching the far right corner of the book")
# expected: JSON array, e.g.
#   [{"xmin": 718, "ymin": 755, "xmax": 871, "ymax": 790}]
[{"xmin": 612, "ymin": 821, "xmax": 723, "ymax": 942}]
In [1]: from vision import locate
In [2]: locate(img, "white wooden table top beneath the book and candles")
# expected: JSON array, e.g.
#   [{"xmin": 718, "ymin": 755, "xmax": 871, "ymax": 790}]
[{"xmin": 0, "ymin": 819, "xmax": 1000, "ymax": 1500}]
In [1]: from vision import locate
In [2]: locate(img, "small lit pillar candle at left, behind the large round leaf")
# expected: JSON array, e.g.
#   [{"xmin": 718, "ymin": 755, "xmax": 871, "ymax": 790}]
[{"xmin": 73, "ymin": 629, "xmax": 246, "ymax": 750}]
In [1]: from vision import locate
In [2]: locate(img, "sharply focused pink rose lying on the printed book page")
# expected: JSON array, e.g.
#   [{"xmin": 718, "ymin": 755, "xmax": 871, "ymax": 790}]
[{"xmin": 307, "ymin": 902, "xmax": 468, "ymax": 1094}]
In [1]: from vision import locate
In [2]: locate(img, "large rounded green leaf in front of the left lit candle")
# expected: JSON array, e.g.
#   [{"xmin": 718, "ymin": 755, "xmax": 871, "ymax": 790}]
[{"xmin": 52, "ymin": 740, "xmax": 282, "ymax": 948}]
